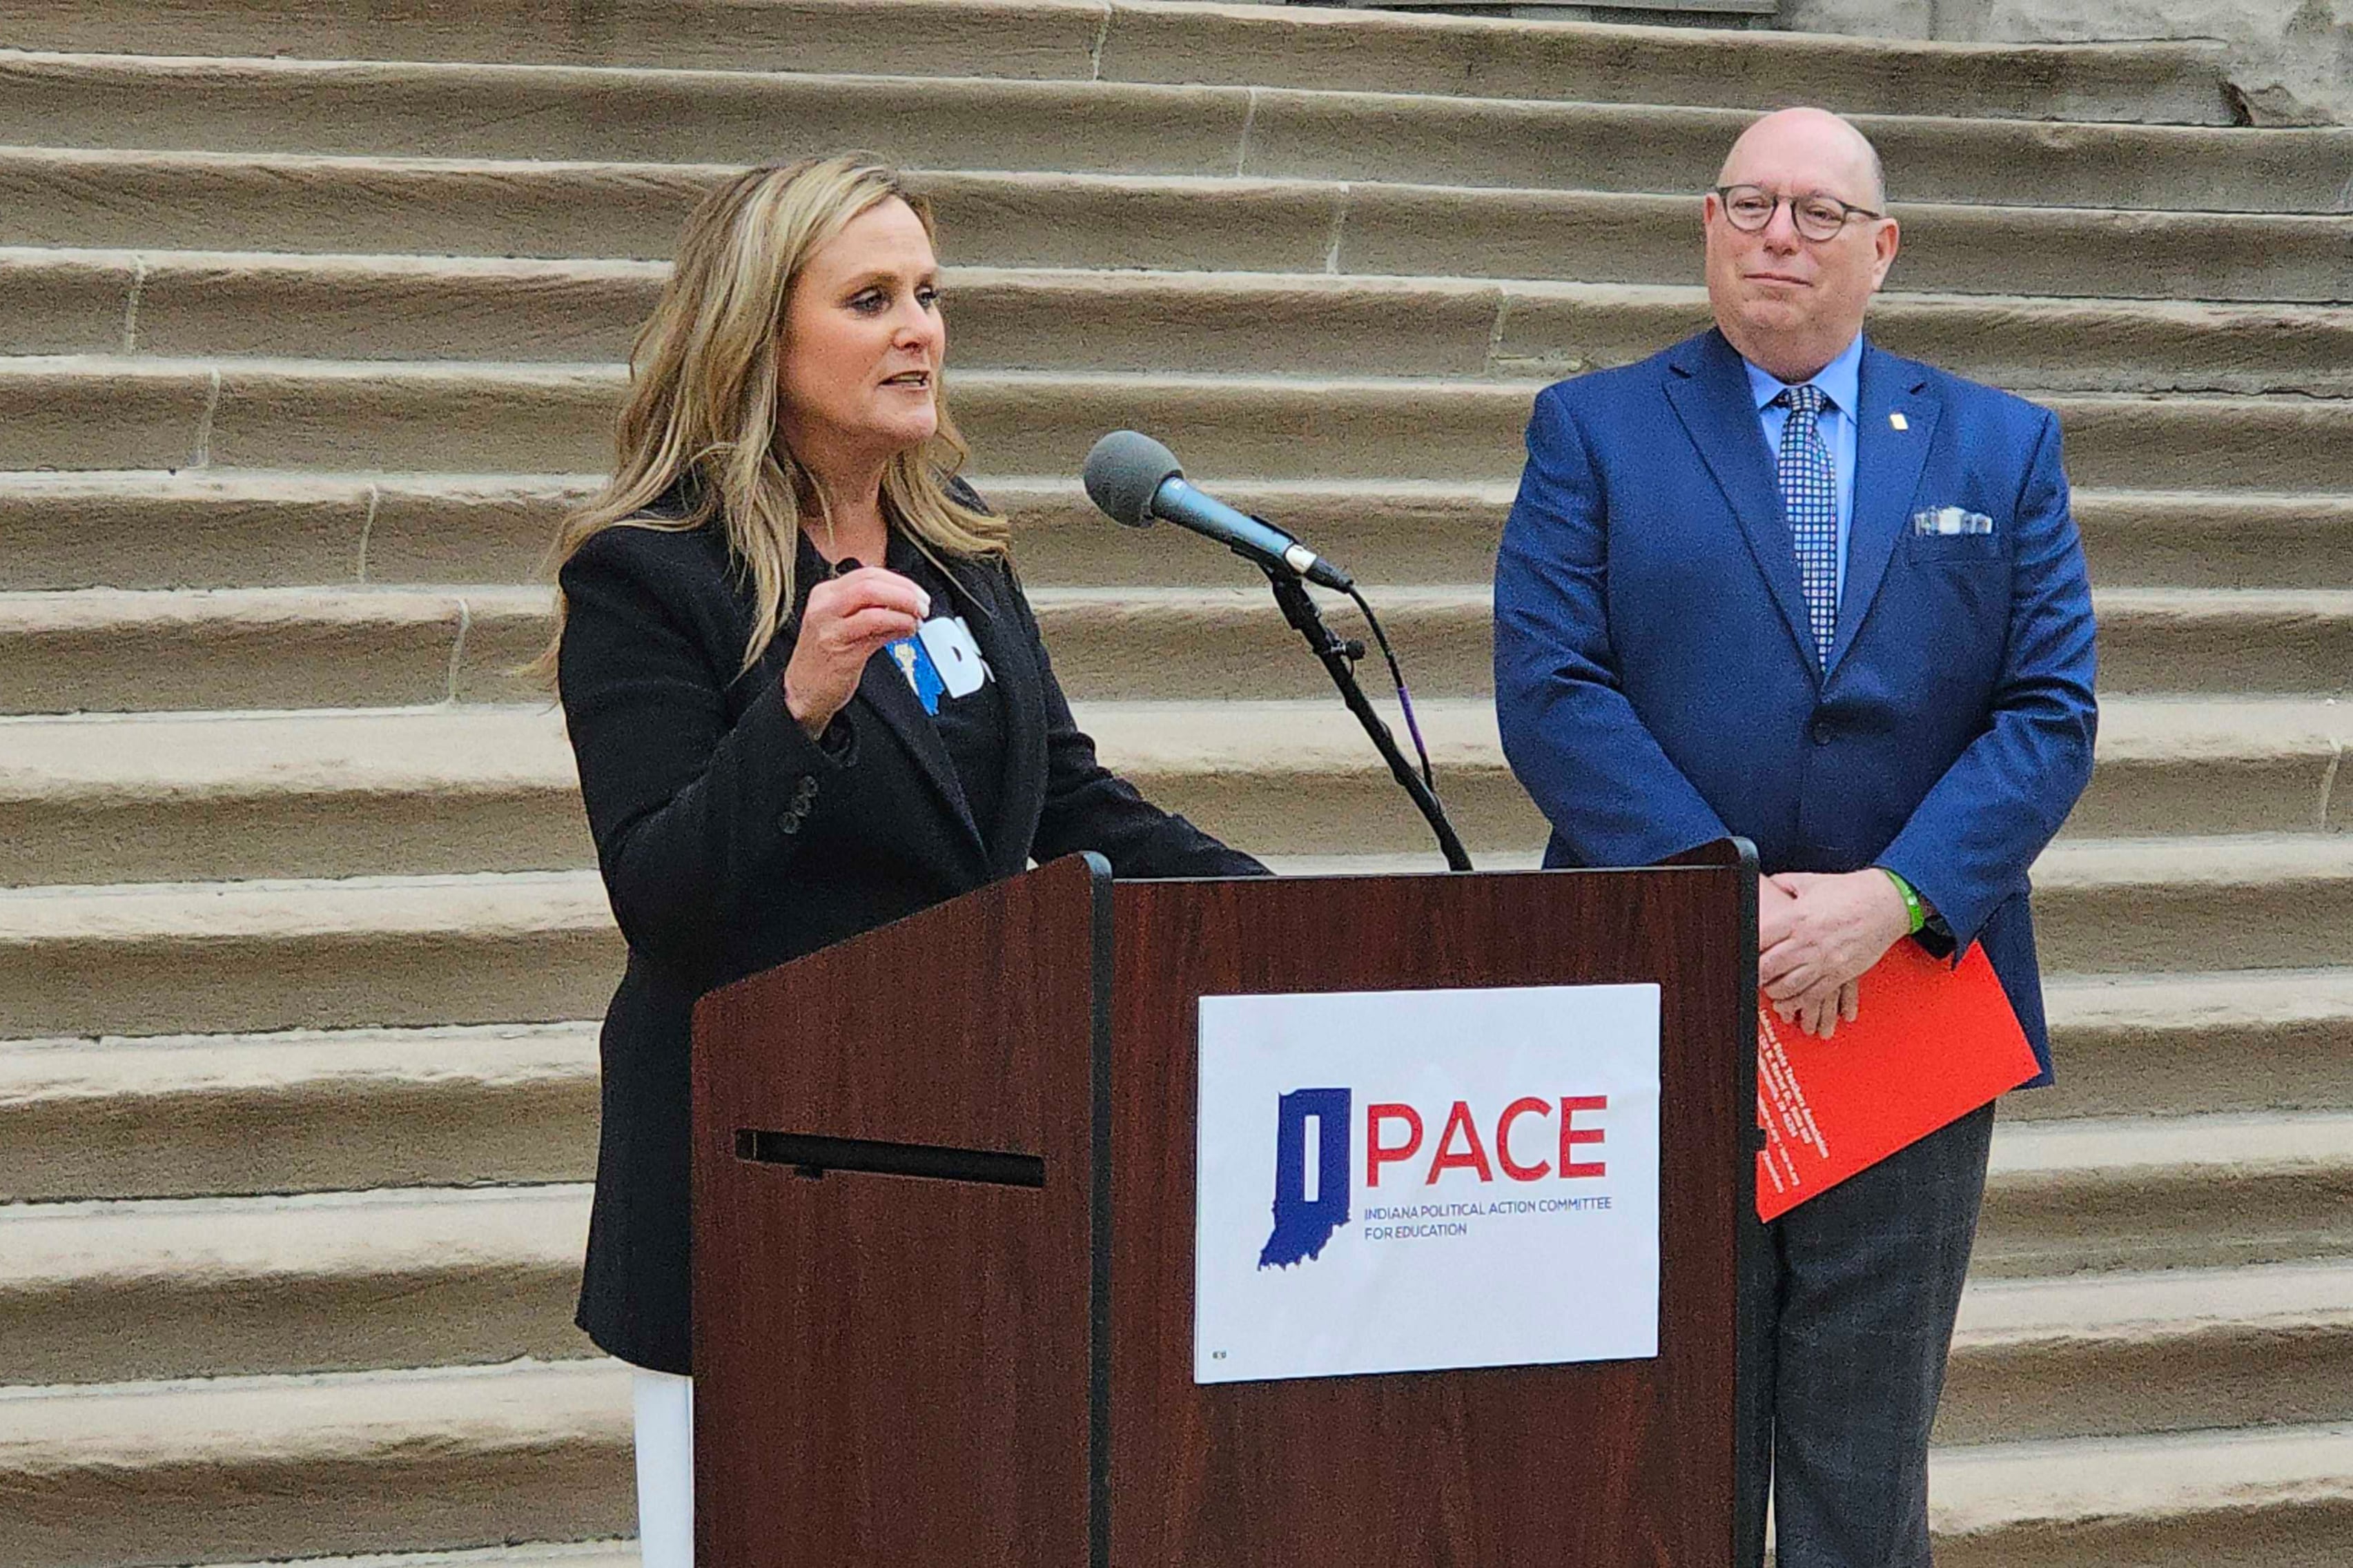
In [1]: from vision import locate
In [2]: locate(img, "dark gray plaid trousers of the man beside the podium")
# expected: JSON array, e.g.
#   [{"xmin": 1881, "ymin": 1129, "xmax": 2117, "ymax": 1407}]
[{"xmin": 1739, "ymin": 1104, "xmax": 1993, "ymax": 1568}]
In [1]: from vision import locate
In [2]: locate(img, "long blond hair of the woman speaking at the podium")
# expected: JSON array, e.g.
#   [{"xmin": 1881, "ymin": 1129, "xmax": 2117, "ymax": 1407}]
[{"xmin": 531, "ymin": 153, "xmax": 1007, "ymax": 678}]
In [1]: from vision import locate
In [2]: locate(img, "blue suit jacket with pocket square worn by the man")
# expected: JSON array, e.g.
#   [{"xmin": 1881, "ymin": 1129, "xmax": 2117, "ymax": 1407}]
[{"xmin": 1494, "ymin": 332, "xmax": 2096, "ymax": 1083}]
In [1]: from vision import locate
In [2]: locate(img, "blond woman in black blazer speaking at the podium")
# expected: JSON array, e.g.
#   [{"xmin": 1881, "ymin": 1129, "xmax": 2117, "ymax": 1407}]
[{"xmin": 541, "ymin": 155, "xmax": 1264, "ymax": 1568}]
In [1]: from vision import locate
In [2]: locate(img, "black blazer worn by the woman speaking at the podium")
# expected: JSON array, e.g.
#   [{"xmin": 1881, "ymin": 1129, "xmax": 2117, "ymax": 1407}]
[{"xmin": 558, "ymin": 501, "xmax": 1264, "ymax": 1373}]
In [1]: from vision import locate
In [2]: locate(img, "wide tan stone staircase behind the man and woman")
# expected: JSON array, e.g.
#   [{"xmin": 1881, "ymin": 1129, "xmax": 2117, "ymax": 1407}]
[{"xmin": 0, "ymin": 0, "xmax": 2353, "ymax": 1568}]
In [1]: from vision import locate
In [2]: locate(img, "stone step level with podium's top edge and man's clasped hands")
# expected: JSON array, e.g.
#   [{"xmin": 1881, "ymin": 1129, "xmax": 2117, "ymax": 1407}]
[{"xmin": 18, "ymin": 828, "xmax": 2353, "ymax": 1036}]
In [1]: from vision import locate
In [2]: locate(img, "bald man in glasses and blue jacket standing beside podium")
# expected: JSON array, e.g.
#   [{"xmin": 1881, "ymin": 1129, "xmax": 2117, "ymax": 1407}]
[{"xmin": 1494, "ymin": 108, "xmax": 2096, "ymax": 1568}]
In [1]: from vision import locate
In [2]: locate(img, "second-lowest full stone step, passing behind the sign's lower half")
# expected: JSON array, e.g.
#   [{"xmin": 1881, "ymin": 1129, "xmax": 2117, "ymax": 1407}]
[{"xmin": 0, "ymin": 1170, "xmax": 2353, "ymax": 1443}]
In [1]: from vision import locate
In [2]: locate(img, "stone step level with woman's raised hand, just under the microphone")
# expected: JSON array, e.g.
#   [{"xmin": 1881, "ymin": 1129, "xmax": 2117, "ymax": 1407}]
[{"xmin": 18, "ymin": 576, "xmax": 2353, "ymax": 711}]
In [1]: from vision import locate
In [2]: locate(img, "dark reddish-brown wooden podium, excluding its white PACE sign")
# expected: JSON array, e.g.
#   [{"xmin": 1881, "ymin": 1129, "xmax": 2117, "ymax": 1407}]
[{"xmin": 694, "ymin": 843, "xmax": 1755, "ymax": 1568}]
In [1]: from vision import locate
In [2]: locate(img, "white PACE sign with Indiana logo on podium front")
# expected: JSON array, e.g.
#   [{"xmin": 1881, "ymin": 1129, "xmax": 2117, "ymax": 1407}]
[{"xmin": 1193, "ymin": 984, "xmax": 1659, "ymax": 1382}]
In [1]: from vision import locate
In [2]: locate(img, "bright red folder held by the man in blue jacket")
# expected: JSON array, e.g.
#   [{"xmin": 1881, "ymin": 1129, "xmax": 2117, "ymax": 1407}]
[{"xmin": 1758, "ymin": 942, "xmax": 2040, "ymax": 1219}]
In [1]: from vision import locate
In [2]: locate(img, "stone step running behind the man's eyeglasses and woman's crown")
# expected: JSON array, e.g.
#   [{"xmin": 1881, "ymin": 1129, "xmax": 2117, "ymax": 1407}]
[{"xmin": 0, "ymin": 157, "xmax": 2353, "ymax": 304}]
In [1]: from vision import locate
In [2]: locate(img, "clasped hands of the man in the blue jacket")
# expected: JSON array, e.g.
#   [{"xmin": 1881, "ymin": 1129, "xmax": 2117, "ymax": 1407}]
[{"xmin": 1758, "ymin": 866, "xmax": 1911, "ymax": 1038}]
